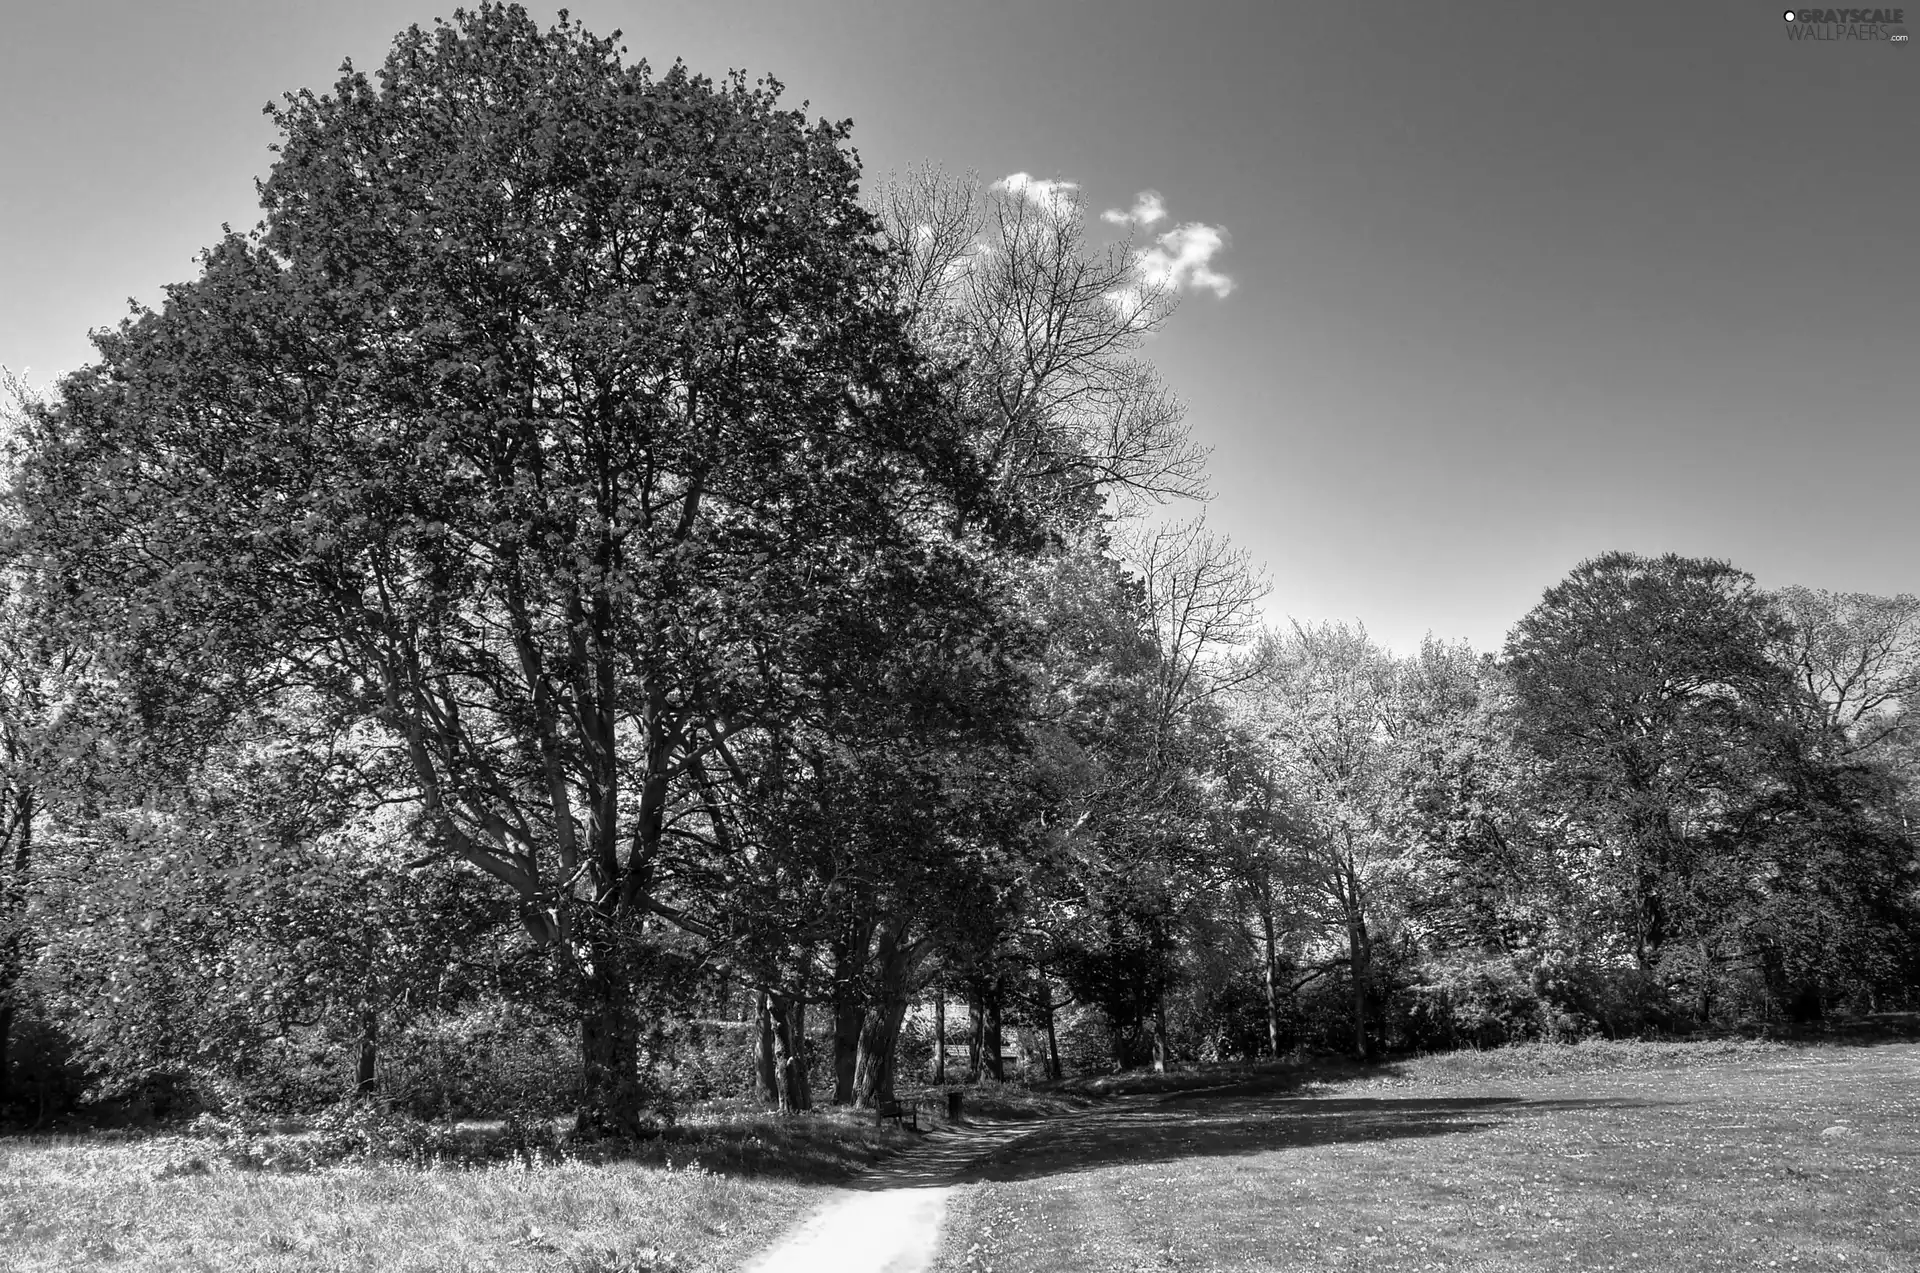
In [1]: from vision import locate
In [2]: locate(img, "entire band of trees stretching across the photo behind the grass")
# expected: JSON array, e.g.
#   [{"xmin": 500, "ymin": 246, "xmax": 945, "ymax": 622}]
[{"xmin": 0, "ymin": 4, "xmax": 1920, "ymax": 1133}]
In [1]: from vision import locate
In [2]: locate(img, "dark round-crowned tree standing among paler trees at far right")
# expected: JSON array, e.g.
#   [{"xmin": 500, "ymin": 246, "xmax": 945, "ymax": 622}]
[{"xmin": 1507, "ymin": 553, "xmax": 1797, "ymax": 990}]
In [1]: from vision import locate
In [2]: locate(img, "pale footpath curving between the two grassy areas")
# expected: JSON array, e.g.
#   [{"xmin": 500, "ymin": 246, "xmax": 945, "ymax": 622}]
[{"xmin": 747, "ymin": 1123, "xmax": 1043, "ymax": 1273}]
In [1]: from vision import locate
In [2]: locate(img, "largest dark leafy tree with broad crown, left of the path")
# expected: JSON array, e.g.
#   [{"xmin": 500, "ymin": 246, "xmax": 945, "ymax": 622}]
[{"xmin": 23, "ymin": 4, "xmax": 1021, "ymax": 1127}]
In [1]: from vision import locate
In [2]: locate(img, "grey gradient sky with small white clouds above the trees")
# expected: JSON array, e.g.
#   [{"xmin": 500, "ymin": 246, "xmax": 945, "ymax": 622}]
[{"xmin": 0, "ymin": 0, "xmax": 1920, "ymax": 651}]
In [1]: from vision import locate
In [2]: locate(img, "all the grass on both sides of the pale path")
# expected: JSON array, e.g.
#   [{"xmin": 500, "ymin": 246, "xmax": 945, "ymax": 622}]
[{"xmin": 0, "ymin": 1043, "xmax": 1920, "ymax": 1273}]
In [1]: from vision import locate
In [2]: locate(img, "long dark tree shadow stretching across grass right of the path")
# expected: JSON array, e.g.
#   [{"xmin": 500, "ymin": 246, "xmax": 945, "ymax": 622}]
[{"xmin": 958, "ymin": 1075, "xmax": 1651, "ymax": 1181}]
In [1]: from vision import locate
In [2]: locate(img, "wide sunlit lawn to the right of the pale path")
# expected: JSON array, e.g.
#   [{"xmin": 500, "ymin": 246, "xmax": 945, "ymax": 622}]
[{"xmin": 939, "ymin": 1045, "xmax": 1920, "ymax": 1273}]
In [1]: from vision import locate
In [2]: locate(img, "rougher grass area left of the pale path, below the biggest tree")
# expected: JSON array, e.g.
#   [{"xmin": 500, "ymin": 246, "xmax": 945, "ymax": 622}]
[{"xmin": 0, "ymin": 1110, "xmax": 908, "ymax": 1273}]
